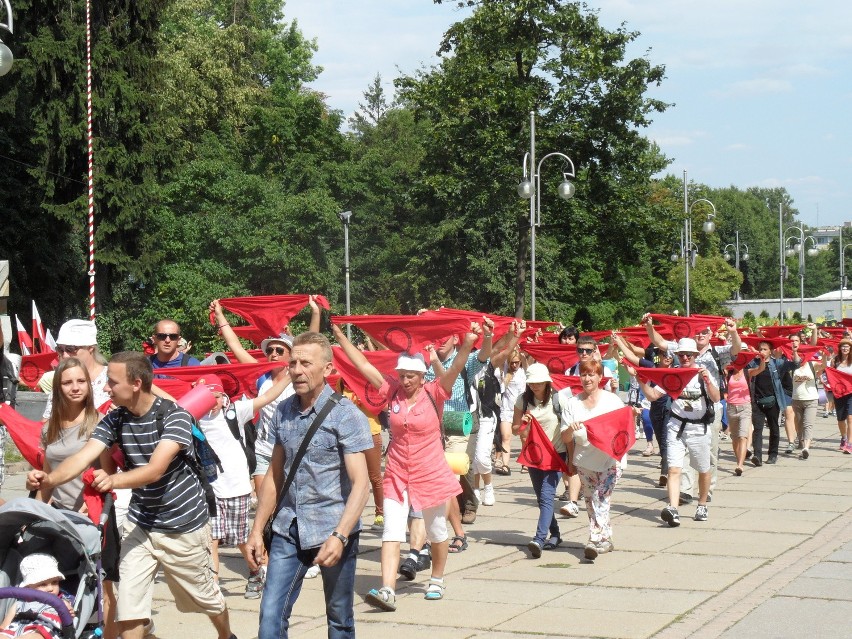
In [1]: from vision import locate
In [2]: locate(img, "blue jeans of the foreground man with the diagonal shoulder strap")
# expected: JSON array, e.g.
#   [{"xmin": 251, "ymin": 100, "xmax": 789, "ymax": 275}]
[{"xmin": 258, "ymin": 519, "xmax": 359, "ymax": 639}]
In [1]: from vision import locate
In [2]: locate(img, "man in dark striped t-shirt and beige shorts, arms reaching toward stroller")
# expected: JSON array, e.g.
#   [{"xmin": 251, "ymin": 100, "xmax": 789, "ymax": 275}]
[{"xmin": 27, "ymin": 351, "xmax": 234, "ymax": 639}]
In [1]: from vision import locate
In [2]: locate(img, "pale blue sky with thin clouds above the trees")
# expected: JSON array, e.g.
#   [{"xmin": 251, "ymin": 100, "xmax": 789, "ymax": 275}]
[{"xmin": 284, "ymin": 0, "xmax": 852, "ymax": 226}]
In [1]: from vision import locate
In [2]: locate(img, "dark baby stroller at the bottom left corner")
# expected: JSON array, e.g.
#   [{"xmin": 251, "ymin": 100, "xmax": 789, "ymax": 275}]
[{"xmin": 0, "ymin": 497, "xmax": 109, "ymax": 639}]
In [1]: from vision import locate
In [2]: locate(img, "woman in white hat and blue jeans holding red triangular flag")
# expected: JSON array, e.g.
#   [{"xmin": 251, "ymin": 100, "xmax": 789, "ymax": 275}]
[{"xmin": 512, "ymin": 364, "xmax": 570, "ymax": 559}]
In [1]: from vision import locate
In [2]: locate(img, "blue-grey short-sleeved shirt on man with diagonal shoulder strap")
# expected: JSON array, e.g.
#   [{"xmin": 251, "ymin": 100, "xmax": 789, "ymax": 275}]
[{"xmin": 272, "ymin": 384, "xmax": 373, "ymax": 548}]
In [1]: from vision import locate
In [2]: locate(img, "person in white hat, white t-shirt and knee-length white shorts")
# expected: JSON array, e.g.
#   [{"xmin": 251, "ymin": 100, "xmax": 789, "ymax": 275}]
[{"xmin": 640, "ymin": 337, "xmax": 719, "ymax": 527}]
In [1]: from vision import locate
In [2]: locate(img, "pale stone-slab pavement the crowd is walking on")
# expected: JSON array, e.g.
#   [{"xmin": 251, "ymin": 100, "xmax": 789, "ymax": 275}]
[{"xmin": 2, "ymin": 417, "xmax": 852, "ymax": 639}]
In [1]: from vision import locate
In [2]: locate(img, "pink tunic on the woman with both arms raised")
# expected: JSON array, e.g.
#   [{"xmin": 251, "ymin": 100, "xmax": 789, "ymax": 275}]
[{"xmin": 379, "ymin": 375, "xmax": 461, "ymax": 510}]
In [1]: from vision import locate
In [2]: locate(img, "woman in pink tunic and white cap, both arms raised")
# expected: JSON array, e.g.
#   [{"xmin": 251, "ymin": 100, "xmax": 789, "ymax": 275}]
[{"xmin": 332, "ymin": 323, "xmax": 482, "ymax": 611}]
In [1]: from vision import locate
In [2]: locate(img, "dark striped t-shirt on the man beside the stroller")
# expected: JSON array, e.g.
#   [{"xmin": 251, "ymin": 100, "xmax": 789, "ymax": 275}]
[{"xmin": 92, "ymin": 397, "xmax": 208, "ymax": 533}]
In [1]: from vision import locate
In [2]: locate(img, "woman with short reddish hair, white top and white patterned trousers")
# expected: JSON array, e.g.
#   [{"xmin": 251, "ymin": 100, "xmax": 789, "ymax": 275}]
[{"xmin": 562, "ymin": 360, "xmax": 627, "ymax": 560}]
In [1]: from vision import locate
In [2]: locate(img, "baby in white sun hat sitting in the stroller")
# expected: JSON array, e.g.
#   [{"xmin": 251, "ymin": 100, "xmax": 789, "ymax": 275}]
[{"xmin": 0, "ymin": 553, "xmax": 74, "ymax": 639}]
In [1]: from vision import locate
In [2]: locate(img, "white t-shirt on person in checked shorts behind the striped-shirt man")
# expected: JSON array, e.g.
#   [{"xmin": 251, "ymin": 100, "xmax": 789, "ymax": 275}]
[{"xmin": 198, "ymin": 399, "xmax": 254, "ymax": 499}]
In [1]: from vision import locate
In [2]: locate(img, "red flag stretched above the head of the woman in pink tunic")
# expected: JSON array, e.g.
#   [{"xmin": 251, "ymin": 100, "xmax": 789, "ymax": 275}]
[{"xmin": 331, "ymin": 313, "xmax": 470, "ymax": 353}]
